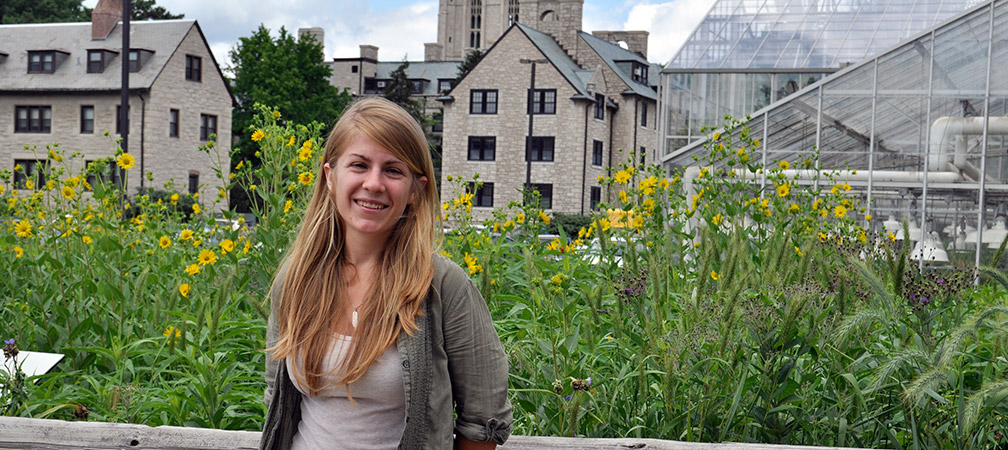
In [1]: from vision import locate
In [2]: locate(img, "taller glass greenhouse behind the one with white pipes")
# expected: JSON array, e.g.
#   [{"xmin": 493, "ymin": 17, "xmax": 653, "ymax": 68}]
[{"xmin": 661, "ymin": 0, "xmax": 977, "ymax": 151}]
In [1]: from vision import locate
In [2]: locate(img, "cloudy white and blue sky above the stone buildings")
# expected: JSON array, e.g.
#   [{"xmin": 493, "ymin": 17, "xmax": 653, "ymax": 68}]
[{"xmin": 84, "ymin": 0, "xmax": 714, "ymax": 69}]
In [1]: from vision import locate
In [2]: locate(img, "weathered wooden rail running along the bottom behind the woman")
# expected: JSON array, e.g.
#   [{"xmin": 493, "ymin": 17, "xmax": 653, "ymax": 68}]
[{"xmin": 0, "ymin": 417, "xmax": 866, "ymax": 450}]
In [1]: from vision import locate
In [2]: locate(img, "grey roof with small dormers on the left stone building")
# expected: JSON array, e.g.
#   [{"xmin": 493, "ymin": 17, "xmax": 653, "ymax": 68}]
[{"xmin": 0, "ymin": 20, "xmax": 234, "ymax": 103}]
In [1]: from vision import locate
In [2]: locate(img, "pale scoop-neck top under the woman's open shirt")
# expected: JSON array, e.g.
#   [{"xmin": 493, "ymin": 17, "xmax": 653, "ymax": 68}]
[{"xmin": 286, "ymin": 334, "xmax": 406, "ymax": 450}]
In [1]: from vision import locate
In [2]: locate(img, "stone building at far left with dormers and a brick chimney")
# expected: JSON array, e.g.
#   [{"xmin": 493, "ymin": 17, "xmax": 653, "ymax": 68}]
[{"xmin": 0, "ymin": 0, "xmax": 234, "ymax": 198}]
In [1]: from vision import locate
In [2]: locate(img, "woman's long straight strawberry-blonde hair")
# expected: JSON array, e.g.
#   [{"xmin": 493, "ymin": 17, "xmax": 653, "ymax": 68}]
[{"xmin": 268, "ymin": 97, "xmax": 438, "ymax": 395}]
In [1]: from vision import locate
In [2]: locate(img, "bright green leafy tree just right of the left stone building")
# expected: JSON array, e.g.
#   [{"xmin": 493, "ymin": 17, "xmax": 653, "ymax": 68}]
[{"xmin": 228, "ymin": 25, "xmax": 352, "ymax": 210}]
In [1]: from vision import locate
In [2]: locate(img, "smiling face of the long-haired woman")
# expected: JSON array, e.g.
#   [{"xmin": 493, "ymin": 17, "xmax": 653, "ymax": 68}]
[{"xmin": 324, "ymin": 136, "xmax": 427, "ymax": 244}]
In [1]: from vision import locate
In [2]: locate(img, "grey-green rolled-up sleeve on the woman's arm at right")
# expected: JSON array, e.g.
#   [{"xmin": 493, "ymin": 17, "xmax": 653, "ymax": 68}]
[{"xmin": 442, "ymin": 266, "xmax": 512, "ymax": 444}]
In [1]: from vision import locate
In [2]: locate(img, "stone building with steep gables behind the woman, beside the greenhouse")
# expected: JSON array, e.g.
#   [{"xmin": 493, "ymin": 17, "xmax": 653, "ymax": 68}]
[{"xmin": 440, "ymin": 22, "xmax": 659, "ymax": 217}]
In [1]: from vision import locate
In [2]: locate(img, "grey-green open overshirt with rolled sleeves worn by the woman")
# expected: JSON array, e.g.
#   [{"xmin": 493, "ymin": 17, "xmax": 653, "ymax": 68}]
[{"xmin": 259, "ymin": 254, "xmax": 511, "ymax": 449}]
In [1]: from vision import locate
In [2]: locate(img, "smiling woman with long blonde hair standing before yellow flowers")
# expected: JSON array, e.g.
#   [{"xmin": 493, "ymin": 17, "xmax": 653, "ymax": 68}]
[{"xmin": 260, "ymin": 98, "xmax": 511, "ymax": 449}]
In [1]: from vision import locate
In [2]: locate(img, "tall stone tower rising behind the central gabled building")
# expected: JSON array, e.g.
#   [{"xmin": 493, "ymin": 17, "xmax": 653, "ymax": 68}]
[{"xmin": 424, "ymin": 0, "xmax": 585, "ymax": 61}]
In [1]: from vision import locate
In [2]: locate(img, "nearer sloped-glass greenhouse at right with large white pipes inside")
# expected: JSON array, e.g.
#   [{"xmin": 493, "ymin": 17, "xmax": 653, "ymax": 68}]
[{"xmin": 662, "ymin": 1, "xmax": 1008, "ymax": 264}]
